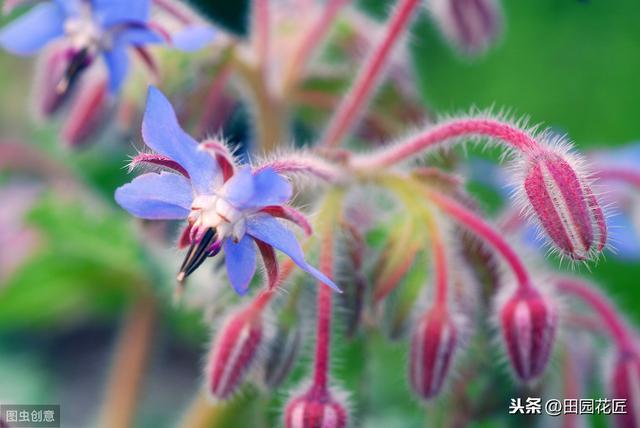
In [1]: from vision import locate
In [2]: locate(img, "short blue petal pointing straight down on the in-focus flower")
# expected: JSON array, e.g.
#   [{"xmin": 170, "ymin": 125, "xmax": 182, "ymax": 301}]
[{"xmin": 223, "ymin": 235, "xmax": 256, "ymax": 296}]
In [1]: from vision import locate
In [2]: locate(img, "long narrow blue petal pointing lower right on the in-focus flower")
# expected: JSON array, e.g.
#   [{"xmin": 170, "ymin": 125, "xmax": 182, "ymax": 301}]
[{"xmin": 247, "ymin": 214, "xmax": 340, "ymax": 291}]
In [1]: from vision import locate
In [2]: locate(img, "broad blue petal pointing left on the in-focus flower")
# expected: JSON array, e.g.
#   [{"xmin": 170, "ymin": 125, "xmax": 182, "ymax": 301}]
[{"xmin": 115, "ymin": 172, "xmax": 192, "ymax": 220}]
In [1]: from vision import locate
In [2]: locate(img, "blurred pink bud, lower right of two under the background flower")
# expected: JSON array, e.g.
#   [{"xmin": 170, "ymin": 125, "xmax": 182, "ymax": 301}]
[{"xmin": 62, "ymin": 79, "xmax": 109, "ymax": 147}]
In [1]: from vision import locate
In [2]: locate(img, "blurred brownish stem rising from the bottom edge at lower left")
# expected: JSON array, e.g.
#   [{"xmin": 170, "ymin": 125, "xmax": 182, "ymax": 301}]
[{"xmin": 98, "ymin": 294, "xmax": 156, "ymax": 427}]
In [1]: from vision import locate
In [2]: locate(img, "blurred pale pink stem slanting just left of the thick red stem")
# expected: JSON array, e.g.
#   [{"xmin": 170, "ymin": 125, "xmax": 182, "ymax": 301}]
[{"xmin": 284, "ymin": 0, "xmax": 347, "ymax": 93}]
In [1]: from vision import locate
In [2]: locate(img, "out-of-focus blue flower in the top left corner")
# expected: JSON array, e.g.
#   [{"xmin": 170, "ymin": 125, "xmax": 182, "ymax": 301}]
[{"xmin": 0, "ymin": 0, "xmax": 163, "ymax": 93}]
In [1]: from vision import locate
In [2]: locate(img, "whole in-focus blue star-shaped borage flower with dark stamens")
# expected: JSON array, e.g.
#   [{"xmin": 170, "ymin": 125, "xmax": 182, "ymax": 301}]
[{"xmin": 115, "ymin": 87, "xmax": 338, "ymax": 295}]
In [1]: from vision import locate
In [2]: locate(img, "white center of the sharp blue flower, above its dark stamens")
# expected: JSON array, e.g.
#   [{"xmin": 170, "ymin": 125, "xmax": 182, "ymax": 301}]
[{"xmin": 189, "ymin": 195, "xmax": 248, "ymax": 241}]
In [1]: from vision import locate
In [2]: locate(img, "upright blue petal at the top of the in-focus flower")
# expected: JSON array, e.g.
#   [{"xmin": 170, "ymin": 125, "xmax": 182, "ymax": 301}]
[{"xmin": 142, "ymin": 86, "xmax": 220, "ymax": 194}]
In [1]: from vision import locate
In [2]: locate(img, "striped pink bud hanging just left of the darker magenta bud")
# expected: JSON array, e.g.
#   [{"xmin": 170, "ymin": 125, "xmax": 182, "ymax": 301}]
[{"xmin": 409, "ymin": 307, "xmax": 459, "ymax": 400}]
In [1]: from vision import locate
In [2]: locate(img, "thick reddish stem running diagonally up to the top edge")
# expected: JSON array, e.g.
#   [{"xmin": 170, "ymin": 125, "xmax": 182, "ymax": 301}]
[{"xmin": 321, "ymin": 0, "xmax": 421, "ymax": 146}]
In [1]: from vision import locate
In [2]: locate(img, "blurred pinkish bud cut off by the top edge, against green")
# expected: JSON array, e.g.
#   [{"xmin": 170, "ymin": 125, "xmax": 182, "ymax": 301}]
[{"xmin": 429, "ymin": 0, "xmax": 502, "ymax": 55}]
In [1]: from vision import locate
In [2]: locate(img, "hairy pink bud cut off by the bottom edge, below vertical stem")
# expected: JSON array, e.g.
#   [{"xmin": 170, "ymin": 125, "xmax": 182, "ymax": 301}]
[{"xmin": 284, "ymin": 387, "xmax": 349, "ymax": 428}]
